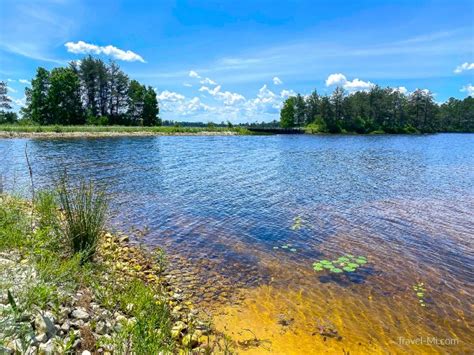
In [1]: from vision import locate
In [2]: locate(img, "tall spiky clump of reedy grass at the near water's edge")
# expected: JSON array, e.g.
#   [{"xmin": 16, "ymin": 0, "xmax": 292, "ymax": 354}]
[{"xmin": 58, "ymin": 177, "xmax": 108, "ymax": 263}]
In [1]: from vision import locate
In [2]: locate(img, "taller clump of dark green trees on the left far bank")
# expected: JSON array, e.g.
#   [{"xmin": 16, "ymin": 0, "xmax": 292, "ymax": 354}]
[{"xmin": 6, "ymin": 56, "xmax": 161, "ymax": 126}]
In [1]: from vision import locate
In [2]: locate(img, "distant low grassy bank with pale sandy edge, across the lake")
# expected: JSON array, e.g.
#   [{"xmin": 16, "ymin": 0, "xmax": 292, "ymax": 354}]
[{"xmin": 0, "ymin": 124, "xmax": 252, "ymax": 136}]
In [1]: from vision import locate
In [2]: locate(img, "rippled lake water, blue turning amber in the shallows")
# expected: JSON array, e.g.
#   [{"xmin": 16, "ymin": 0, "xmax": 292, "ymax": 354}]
[{"xmin": 0, "ymin": 134, "xmax": 474, "ymax": 354}]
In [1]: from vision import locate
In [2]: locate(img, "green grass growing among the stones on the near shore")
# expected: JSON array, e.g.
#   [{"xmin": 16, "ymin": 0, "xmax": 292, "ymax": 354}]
[{"xmin": 0, "ymin": 191, "xmax": 181, "ymax": 354}]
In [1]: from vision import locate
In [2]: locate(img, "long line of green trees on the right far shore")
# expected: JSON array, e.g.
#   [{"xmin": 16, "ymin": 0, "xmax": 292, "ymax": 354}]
[{"xmin": 280, "ymin": 86, "xmax": 474, "ymax": 133}]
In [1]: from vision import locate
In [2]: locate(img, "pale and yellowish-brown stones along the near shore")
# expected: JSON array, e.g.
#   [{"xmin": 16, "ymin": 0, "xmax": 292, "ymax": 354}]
[{"xmin": 0, "ymin": 233, "xmax": 219, "ymax": 355}]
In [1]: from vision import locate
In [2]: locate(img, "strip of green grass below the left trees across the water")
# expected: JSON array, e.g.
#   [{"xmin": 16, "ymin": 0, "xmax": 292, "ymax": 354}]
[{"xmin": 0, "ymin": 124, "xmax": 252, "ymax": 135}]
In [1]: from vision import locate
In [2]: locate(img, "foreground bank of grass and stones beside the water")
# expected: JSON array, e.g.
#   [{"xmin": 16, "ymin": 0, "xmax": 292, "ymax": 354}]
[{"xmin": 0, "ymin": 185, "xmax": 227, "ymax": 354}]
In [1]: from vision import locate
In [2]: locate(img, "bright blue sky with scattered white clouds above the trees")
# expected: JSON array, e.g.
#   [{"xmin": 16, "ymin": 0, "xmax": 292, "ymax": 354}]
[{"xmin": 0, "ymin": 0, "xmax": 474, "ymax": 122}]
